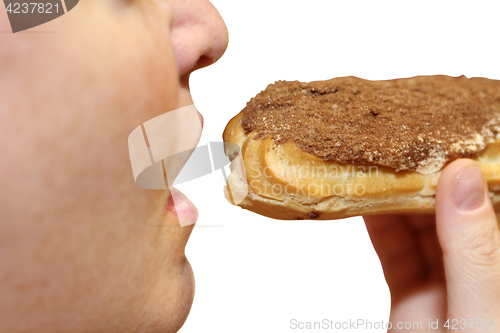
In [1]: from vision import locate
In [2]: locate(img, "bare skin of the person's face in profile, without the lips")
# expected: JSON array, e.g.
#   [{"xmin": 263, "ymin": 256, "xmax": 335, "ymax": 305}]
[{"xmin": 0, "ymin": 0, "xmax": 227, "ymax": 333}]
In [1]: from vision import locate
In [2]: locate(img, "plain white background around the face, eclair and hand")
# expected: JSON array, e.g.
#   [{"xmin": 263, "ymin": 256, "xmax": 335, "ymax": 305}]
[{"xmin": 178, "ymin": 0, "xmax": 500, "ymax": 333}]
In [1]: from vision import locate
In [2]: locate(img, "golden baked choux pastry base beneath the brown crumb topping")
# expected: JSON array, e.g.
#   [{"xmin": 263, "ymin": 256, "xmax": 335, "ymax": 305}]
[{"xmin": 223, "ymin": 76, "xmax": 500, "ymax": 220}]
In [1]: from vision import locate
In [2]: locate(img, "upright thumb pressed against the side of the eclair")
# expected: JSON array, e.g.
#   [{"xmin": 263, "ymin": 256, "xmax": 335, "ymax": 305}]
[{"xmin": 436, "ymin": 159, "xmax": 500, "ymax": 320}]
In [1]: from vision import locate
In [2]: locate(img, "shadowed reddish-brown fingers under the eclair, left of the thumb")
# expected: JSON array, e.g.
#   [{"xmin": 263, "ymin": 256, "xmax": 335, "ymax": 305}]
[{"xmin": 364, "ymin": 215, "xmax": 446, "ymax": 331}]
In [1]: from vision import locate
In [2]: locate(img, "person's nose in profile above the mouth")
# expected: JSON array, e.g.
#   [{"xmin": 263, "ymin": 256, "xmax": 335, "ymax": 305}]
[{"xmin": 170, "ymin": 0, "xmax": 228, "ymax": 76}]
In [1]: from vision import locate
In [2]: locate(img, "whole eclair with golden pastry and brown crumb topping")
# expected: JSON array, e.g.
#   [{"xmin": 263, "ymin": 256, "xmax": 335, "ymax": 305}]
[{"xmin": 223, "ymin": 75, "xmax": 500, "ymax": 219}]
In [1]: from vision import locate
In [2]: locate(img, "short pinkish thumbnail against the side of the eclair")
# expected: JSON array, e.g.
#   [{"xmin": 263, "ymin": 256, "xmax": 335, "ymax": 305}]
[{"xmin": 453, "ymin": 165, "xmax": 485, "ymax": 210}]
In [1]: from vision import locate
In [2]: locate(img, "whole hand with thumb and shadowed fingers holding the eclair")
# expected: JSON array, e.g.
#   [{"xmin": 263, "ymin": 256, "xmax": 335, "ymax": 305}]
[{"xmin": 364, "ymin": 159, "xmax": 500, "ymax": 332}]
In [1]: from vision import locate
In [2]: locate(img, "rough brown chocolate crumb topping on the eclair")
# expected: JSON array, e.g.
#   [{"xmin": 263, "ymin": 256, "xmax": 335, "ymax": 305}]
[{"xmin": 242, "ymin": 76, "xmax": 500, "ymax": 171}]
